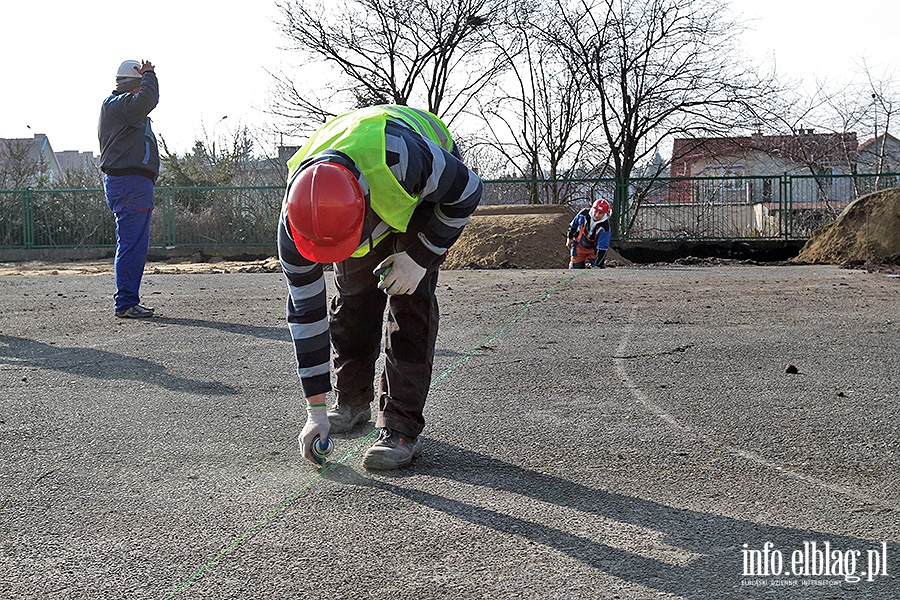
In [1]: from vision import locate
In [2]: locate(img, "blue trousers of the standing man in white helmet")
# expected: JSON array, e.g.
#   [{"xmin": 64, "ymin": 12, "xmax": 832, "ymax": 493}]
[{"xmin": 103, "ymin": 175, "xmax": 153, "ymax": 312}]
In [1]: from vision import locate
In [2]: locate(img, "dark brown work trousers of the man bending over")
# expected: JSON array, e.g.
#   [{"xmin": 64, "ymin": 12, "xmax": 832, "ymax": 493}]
[{"xmin": 329, "ymin": 234, "xmax": 442, "ymax": 437}]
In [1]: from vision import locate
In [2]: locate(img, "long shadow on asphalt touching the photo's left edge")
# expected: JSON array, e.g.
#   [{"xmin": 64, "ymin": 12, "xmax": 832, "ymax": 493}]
[{"xmin": 0, "ymin": 334, "xmax": 238, "ymax": 396}]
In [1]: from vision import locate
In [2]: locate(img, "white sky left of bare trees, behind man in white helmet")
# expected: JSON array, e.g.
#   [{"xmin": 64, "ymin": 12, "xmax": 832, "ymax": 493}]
[{"xmin": 0, "ymin": 0, "xmax": 285, "ymax": 154}]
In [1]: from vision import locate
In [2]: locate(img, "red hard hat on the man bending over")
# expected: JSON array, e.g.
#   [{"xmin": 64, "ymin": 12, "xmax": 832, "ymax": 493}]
[{"xmin": 287, "ymin": 162, "xmax": 366, "ymax": 263}]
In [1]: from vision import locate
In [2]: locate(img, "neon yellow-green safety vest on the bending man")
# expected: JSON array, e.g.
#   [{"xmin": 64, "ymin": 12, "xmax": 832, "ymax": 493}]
[{"xmin": 287, "ymin": 105, "xmax": 453, "ymax": 245}]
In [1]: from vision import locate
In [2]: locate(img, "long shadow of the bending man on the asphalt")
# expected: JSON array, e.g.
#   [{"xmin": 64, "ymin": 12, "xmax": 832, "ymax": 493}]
[{"xmin": 324, "ymin": 439, "xmax": 898, "ymax": 600}]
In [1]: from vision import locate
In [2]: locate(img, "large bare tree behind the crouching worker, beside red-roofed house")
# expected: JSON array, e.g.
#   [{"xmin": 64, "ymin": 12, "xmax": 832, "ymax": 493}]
[{"xmin": 546, "ymin": 0, "xmax": 774, "ymax": 229}]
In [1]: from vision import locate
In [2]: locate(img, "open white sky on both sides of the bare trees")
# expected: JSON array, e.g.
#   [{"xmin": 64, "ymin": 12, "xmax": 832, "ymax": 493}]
[{"xmin": 0, "ymin": 0, "xmax": 900, "ymax": 154}]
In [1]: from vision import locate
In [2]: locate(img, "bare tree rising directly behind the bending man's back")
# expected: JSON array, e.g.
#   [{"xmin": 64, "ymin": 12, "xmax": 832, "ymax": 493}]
[{"xmin": 272, "ymin": 0, "xmax": 508, "ymax": 128}]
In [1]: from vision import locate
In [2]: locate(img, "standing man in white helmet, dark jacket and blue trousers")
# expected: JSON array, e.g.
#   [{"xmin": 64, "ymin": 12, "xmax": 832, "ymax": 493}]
[{"xmin": 97, "ymin": 60, "xmax": 159, "ymax": 319}]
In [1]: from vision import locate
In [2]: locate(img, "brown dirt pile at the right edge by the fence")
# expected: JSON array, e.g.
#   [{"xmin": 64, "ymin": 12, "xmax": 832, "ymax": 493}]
[{"xmin": 792, "ymin": 188, "xmax": 900, "ymax": 264}]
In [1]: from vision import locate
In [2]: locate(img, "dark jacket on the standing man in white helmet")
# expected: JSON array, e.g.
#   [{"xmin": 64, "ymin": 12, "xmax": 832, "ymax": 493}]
[{"xmin": 97, "ymin": 71, "xmax": 159, "ymax": 181}]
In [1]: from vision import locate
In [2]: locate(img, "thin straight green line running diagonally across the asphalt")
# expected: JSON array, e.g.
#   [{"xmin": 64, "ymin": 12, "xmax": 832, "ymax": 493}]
[{"xmin": 165, "ymin": 271, "xmax": 586, "ymax": 600}]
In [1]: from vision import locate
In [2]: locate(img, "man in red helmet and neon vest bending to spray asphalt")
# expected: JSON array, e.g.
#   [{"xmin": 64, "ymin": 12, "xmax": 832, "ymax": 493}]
[{"xmin": 278, "ymin": 105, "xmax": 482, "ymax": 469}]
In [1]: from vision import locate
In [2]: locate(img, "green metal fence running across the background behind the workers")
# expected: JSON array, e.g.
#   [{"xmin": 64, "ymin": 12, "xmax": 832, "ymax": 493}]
[{"xmin": 0, "ymin": 174, "xmax": 900, "ymax": 249}]
